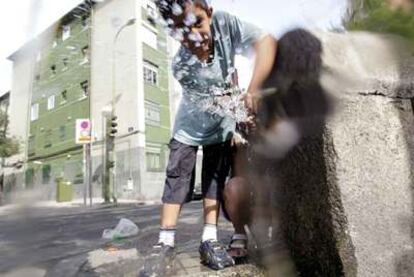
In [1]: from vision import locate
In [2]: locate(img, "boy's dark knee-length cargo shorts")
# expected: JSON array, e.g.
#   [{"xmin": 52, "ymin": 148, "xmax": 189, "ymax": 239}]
[{"xmin": 162, "ymin": 138, "xmax": 232, "ymax": 204}]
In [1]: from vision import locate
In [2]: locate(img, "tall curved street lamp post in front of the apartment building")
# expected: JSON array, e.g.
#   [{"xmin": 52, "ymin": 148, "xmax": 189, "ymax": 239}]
[{"xmin": 104, "ymin": 18, "xmax": 136, "ymax": 203}]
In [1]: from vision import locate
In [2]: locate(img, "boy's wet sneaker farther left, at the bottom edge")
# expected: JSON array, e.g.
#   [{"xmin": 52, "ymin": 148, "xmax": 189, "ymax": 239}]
[{"xmin": 138, "ymin": 243, "xmax": 175, "ymax": 277}]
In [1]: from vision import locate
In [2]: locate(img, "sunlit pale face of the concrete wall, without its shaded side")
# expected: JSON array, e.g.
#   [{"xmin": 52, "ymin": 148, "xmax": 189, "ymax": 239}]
[{"xmin": 323, "ymin": 33, "xmax": 414, "ymax": 276}]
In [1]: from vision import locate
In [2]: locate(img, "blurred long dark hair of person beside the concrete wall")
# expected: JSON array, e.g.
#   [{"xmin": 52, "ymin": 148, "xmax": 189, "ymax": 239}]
[{"xmin": 258, "ymin": 29, "xmax": 331, "ymax": 135}]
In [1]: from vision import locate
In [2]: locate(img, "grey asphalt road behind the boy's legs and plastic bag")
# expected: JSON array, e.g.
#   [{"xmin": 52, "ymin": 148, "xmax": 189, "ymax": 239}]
[{"xmin": 0, "ymin": 201, "xmax": 231, "ymax": 275}]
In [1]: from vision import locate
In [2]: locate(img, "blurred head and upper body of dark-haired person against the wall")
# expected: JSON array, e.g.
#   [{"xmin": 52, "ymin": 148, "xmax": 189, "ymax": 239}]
[{"xmin": 255, "ymin": 29, "xmax": 332, "ymax": 158}]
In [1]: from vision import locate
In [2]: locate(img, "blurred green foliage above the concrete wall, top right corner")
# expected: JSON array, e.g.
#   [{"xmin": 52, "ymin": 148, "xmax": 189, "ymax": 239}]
[{"xmin": 346, "ymin": 0, "xmax": 414, "ymax": 46}]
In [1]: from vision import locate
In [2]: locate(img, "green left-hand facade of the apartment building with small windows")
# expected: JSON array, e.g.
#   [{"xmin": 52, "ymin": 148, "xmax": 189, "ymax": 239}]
[{"xmin": 26, "ymin": 9, "xmax": 91, "ymax": 192}]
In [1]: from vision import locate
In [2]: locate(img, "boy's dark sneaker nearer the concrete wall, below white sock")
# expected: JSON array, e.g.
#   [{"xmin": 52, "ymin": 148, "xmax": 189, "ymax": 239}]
[{"xmin": 198, "ymin": 240, "xmax": 234, "ymax": 270}]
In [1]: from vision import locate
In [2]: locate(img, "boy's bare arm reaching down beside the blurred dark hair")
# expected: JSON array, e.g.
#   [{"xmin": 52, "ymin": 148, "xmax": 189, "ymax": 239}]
[{"xmin": 245, "ymin": 35, "xmax": 277, "ymax": 114}]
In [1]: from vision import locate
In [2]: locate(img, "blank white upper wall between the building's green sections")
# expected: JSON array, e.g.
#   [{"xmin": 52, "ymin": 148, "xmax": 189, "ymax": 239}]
[{"xmin": 91, "ymin": 0, "xmax": 139, "ymax": 148}]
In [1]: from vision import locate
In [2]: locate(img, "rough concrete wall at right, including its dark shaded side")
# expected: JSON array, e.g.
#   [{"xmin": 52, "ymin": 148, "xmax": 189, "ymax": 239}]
[{"xmin": 277, "ymin": 33, "xmax": 414, "ymax": 277}]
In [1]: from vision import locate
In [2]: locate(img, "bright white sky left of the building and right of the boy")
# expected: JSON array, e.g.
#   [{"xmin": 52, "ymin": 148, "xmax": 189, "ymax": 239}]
[{"xmin": 0, "ymin": 0, "xmax": 347, "ymax": 95}]
